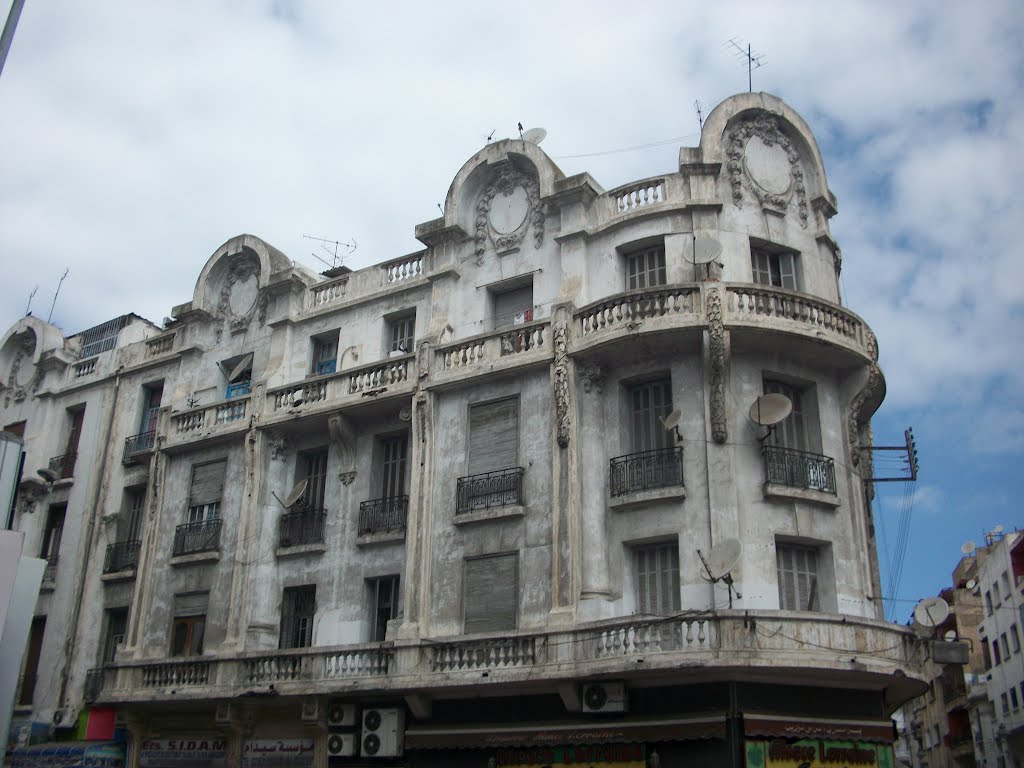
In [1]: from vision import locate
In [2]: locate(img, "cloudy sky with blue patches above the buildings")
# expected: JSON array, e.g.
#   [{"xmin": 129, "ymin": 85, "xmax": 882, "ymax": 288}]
[{"xmin": 0, "ymin": 0, "xmax": 1024, "ymax": 621}]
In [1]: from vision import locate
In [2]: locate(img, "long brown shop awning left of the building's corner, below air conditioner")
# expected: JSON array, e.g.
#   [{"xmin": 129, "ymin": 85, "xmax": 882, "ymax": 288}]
[{"xmin": 406, "ymin": 713, "xmax": 725, "ymax": 750}]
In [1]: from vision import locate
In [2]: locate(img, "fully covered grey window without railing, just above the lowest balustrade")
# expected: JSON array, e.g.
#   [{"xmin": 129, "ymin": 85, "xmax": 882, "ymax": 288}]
[{"xmin": 463, "ymin": 553, "xmax": 519, "ymax": 634}]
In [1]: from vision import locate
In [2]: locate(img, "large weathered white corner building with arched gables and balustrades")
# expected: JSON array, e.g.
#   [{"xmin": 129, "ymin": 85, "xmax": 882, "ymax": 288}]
[{"xmin": 0, "ymin": 94, "xmax": 926, "ymax": 768}]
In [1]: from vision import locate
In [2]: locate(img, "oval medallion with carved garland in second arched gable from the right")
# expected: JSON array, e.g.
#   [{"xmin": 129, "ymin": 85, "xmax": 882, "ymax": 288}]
[{"xmin": 475, "ymin": 162, "xmax": 544, "ymax": 265}]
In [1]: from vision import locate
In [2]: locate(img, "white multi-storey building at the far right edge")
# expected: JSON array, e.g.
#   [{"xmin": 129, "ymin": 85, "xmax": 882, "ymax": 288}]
[{"xmin": 978, "ymin": 530, "xmax": 1024, "ymax": 768}]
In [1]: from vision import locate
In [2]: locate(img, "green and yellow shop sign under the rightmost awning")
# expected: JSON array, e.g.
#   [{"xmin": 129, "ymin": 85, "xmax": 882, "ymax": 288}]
[{"xmin": 746, "ymin": 738, "xmax": 895, "ymax": 768}]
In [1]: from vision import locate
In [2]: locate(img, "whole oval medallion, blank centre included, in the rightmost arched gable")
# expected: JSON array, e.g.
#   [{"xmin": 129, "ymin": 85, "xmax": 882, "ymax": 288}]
[{"xmin": 726, "ymin": 112, "xmax": 810, "ymax": 228}]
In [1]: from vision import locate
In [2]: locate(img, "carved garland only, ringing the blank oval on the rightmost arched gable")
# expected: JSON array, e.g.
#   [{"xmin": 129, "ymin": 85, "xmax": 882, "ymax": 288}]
[{"xmin": 726, "ymin": 112, "xmax": 810, "ymax": 229}]
